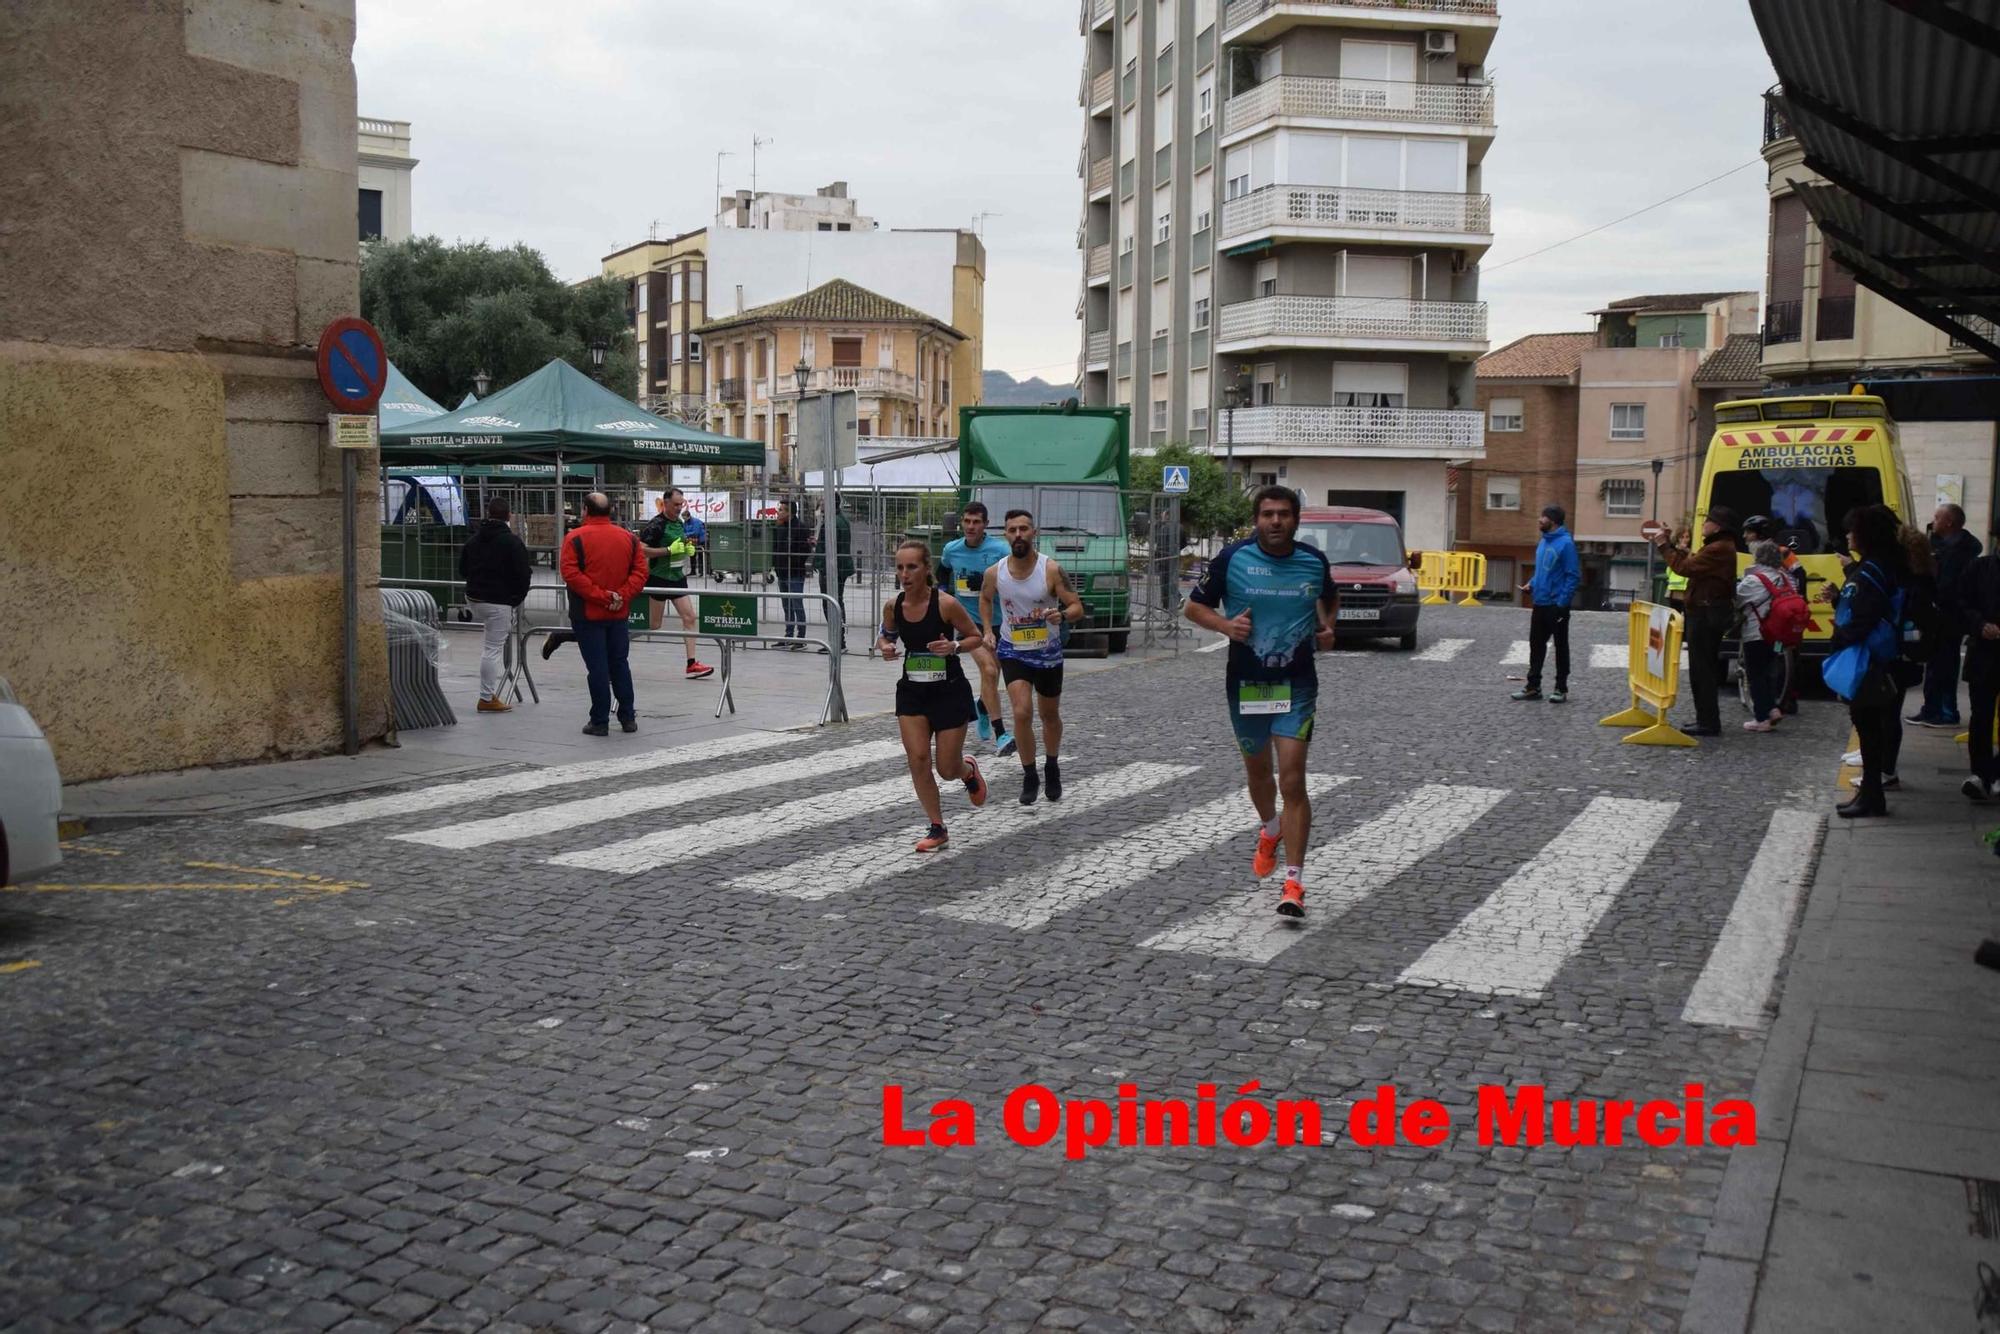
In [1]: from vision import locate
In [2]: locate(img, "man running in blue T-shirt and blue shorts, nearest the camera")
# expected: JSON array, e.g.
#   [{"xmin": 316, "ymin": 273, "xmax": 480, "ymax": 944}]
[{"xmin": 1188, "ymin": 486, "xmax": 1340, "ymax": 918}]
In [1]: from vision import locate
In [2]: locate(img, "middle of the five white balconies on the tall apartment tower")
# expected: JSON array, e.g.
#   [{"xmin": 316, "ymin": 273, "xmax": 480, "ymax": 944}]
[{"xmin": 1222, "ymin": 186, "xmax": 1492, "ymax": 258}]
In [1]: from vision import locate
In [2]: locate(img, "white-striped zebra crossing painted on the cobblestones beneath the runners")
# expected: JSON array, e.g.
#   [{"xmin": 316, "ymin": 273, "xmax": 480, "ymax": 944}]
[{"xmin": 250, "ymin": 720, "xmax": 1824, "ymax": 1028}]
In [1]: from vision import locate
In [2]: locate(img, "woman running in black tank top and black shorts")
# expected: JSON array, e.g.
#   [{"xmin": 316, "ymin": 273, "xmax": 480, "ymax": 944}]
[{"xmin": 876, "ymin": 542, "xmax": 986, "ymax": 852}]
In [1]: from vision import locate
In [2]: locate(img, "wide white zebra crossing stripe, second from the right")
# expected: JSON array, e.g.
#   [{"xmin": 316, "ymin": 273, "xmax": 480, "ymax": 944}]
[{"xmin": 1398, "ymin": 796, "xmax": 1680, "ymax": 996}]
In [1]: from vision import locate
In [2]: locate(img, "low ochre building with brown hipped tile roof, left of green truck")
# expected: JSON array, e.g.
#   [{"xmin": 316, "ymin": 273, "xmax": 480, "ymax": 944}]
[{"xmin": 700, "ymin": 278, "xmax": 966, "ymax": 476}]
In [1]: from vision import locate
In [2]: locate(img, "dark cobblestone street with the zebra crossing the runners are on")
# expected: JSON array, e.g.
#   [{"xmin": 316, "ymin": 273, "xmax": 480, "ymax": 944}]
[{"xmin": 0, "ymin": 608, "xmax": 1846, "ymax": 1332}]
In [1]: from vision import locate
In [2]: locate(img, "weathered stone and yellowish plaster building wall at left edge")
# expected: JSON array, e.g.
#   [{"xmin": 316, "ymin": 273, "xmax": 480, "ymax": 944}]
[{"xmin": 0, "ymin": 0, "xmax": 388, "ymax": 780}]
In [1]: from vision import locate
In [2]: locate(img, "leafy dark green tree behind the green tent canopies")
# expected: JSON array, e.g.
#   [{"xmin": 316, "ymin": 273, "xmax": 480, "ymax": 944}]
[{"xmin": 362, "ymin": 236, "xmax": 638, "ymax": 406}]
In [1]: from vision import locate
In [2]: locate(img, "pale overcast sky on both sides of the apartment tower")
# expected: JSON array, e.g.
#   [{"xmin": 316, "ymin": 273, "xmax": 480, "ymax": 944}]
[{"xmin": 354, "ymin": 0, "xmax": 1772, "ymax": 382}]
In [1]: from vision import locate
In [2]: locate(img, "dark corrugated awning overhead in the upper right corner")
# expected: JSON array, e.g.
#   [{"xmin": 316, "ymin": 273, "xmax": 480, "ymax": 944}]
[{"xmin": 1750, "ymin": 0, "xmax": 2000, "ymax": 362}]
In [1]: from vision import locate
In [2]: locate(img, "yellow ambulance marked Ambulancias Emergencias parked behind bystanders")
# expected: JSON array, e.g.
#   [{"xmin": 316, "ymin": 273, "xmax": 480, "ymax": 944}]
[{"xmin": 1668, "ymin": 392, "xmax": 1910, "ymax": 656}]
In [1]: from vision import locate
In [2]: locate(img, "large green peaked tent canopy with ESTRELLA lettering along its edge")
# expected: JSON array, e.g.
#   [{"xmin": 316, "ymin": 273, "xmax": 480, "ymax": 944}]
[{"xmin": 382, "ymin": 360, "xmax": 764, "ymax": 468}]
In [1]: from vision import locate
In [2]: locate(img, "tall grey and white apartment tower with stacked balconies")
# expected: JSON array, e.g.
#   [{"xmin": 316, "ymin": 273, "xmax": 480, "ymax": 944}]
[{"xmin": 1078, "ymin": 0, "xmax": 1500, "ymax": 546}]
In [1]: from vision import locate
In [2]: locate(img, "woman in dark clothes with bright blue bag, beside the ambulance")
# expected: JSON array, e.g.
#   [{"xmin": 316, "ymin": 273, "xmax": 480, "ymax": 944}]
[{"xmin": 1824, "ymin": 504, "xmax": 1910, "ymax": 820}]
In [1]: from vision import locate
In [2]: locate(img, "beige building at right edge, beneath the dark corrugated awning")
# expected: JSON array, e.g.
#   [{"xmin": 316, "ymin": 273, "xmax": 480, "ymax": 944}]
[{"xmin": 1764, "ymin": 102, "xmax": 2000, "ymax": 538}]
